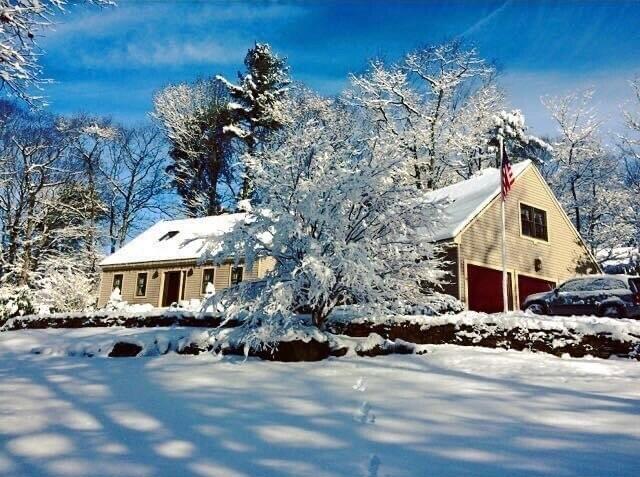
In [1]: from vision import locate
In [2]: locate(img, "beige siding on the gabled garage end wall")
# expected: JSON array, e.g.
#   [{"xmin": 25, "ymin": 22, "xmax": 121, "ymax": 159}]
[{"xmin": 456, "ymin": 166, "xmax": 598, "ymax": 301}]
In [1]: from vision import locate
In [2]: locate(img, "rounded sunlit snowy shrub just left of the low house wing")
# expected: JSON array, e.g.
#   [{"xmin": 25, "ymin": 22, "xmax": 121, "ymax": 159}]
[{"xmin": 37, "ymin": 268, "xmax": 97, "ymax": 312}]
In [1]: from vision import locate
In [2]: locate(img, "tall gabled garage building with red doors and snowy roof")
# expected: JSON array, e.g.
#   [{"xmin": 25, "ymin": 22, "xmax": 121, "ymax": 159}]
[{"xmin": 429, "ymin": 161, "xmax": 600, "ymax": 313}]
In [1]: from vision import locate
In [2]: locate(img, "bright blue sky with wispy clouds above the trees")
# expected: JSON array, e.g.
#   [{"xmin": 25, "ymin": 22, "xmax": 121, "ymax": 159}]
[{"xmin": 40, "ymin": 0, "xmax": 640, "ymax": 134}]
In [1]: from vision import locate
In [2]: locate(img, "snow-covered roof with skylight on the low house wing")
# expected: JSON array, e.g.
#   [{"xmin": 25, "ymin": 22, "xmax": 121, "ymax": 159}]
[{"xmin": 100, "ymin": 213, "xmax": 246, "ymax": 266}]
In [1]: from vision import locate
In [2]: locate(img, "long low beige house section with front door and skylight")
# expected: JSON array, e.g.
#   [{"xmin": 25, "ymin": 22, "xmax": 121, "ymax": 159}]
[{"xmin": 98, "ymin": 213, "xmax": 273, "ymax": 307}]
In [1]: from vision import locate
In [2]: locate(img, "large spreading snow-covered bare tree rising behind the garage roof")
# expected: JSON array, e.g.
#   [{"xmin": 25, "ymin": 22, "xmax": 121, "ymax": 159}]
[{"xmin": 345, "ymin": 42, "xmax": 503, "ymax": 189}]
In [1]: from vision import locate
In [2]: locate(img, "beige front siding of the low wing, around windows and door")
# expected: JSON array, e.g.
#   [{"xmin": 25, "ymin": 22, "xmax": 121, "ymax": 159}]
[{"xmin": 98, "ymin": 259, "xmax": 272, "ymax": 307}]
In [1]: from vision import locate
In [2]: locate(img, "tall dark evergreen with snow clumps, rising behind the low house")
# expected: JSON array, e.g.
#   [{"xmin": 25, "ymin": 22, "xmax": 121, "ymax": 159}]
[{"xmin": 217, "ymin": 43, "xmax": 291, "ymax": 199}]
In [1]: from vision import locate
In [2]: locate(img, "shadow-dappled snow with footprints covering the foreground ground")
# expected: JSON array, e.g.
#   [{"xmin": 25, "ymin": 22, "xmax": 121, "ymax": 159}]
[{"xmin": 0, "ymin": 328, "xmax": 640, "ymax": 477}]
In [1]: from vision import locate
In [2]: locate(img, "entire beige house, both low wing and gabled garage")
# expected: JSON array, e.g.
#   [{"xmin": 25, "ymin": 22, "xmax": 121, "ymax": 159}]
[{"xmin": 98, "ymin": 161, "xmax": 600, "ymax": 312}]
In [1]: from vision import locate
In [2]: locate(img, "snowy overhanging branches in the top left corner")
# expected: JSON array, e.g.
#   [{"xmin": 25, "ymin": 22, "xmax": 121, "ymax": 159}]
[{"xmin": 0, "ymin": 0, "xmax": 115, "ymax": 102}]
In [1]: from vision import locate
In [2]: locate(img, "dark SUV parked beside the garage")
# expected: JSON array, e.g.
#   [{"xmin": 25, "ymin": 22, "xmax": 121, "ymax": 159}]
[{"xmin": 522, "ymin": 275, "xmax": 640, "ymax": 318}]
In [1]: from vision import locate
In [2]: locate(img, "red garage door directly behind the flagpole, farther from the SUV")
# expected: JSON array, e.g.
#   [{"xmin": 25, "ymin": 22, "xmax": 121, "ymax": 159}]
[{"xmin": 467, "ymin": 265, "xmax": 513, "ymax": 313}]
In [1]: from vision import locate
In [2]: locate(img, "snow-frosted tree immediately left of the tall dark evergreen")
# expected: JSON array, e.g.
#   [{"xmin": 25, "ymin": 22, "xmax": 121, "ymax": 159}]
[{"xmin": 153, "ymin": 79, "xmax": 236, "ymax": 217}]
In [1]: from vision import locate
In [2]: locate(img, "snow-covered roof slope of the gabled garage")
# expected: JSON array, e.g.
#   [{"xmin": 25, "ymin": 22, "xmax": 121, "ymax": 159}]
[{"xmin": 427, "ymin": 160, "xmax": 531, "ymax": 241}]
